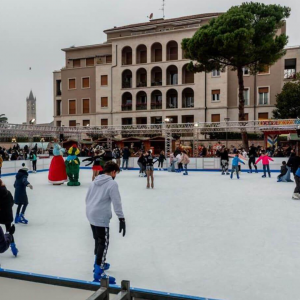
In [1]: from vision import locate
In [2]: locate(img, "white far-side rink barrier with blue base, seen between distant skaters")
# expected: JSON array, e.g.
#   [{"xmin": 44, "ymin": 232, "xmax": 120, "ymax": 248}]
[{"xmin": 2, "ymin": 157, "xmax": 288, "ymax": 176}]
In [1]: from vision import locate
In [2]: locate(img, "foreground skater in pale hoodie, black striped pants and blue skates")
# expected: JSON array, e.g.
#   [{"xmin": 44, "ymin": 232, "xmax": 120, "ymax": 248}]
[{"xmin": 86, "ymin": 161, "xmax": 126, "ymax": 284}]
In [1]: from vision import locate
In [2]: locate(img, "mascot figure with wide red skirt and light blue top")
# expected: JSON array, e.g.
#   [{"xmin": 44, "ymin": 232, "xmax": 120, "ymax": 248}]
[{"xmin": 48, "ymin": 141, "xmax": 68, "ymax": 185}]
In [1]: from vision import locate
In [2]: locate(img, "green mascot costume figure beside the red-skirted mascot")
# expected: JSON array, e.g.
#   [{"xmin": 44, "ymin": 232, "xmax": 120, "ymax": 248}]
[{"xmin": 65, "ymin": 144, "xmax": 80, "ymax": 186}]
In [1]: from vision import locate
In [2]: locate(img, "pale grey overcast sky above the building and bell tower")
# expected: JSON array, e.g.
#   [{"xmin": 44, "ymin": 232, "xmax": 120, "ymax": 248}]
[{"xmin": 0, "ymin": 0, "xmax": 300, "ymax": 123}]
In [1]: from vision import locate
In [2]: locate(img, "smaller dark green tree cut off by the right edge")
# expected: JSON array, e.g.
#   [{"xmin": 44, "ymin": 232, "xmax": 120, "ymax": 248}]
[{"xmin": 273, "ymin": 73, "xmax": 300, "ymax": 119}]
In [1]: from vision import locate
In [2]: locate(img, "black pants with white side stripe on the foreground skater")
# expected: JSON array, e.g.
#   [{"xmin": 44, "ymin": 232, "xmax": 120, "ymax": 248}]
[{"xmin": 91, "ymin": 225, "xmax": 109, "ymax": 269}]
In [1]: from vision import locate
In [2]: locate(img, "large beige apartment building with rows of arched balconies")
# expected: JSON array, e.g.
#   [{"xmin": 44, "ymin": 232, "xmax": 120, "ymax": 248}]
[{"xmin": 53, "ymin": 13, "xmax": 300, "ymax": 126}]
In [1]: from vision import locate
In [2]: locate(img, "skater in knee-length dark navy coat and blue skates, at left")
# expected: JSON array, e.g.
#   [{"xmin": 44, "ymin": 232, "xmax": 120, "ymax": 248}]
[{"xmin": 14, "ymin": 163, "xmax": 33, "ymax": 224}]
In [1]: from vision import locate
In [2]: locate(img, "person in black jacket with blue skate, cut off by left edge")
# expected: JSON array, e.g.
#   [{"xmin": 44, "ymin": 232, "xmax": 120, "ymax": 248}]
[{"xmin": 0, "ymin": 179, "xmax": 19, "ymax": 257}]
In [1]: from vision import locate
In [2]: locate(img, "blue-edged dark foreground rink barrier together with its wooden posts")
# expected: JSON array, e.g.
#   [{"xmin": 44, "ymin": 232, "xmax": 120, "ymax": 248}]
[{"xmin": 0, "ymin": 268, "xmax": 223, "ymax": 300}]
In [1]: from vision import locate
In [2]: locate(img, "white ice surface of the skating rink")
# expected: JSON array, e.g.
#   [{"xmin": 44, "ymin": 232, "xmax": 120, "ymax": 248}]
[{"xmin": 0, "ymin": 170, "xmax": 300, "ymax": 300}]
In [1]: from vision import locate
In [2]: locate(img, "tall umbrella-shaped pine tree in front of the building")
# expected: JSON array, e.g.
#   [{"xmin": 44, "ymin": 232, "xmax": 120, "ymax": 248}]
[{"xmin": 182, "ymin": 2, "xmax": 290, "ymax": 149}]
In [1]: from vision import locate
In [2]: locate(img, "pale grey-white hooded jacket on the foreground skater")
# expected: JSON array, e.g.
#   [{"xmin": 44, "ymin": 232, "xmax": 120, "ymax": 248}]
[{"xmin": 85, "ymin": 174, "xmax": 124, "ymax": 227}]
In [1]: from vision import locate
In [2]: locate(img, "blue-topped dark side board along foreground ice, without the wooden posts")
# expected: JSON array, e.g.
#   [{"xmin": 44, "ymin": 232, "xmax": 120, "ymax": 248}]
[{"xmin": 0, "ymin": 268, "xmax": 220, "ymax": 300}]
